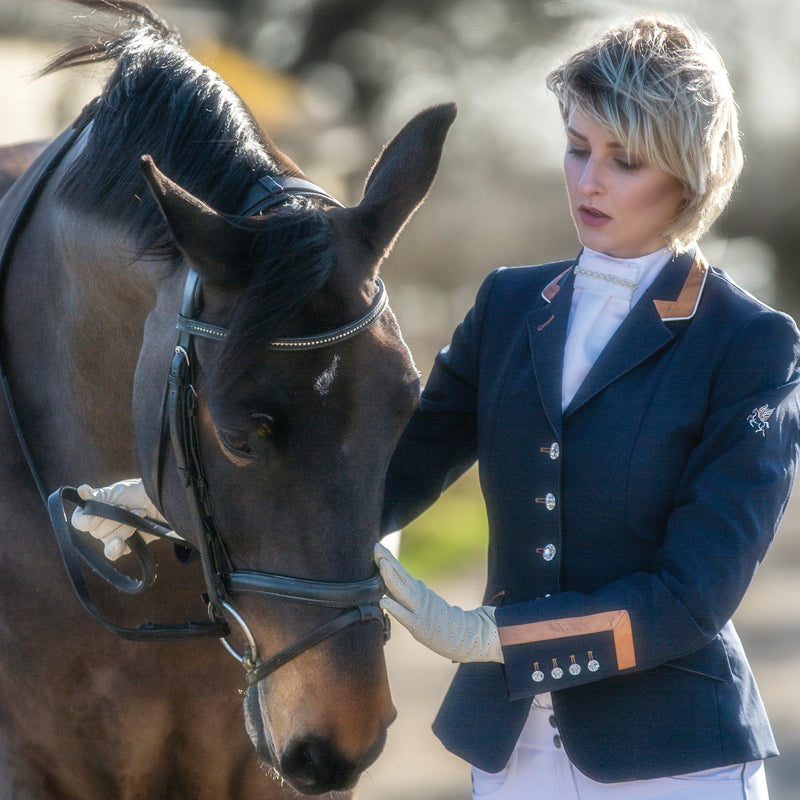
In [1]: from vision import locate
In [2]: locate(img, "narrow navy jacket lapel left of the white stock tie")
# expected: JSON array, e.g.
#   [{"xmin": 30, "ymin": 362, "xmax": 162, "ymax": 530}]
[{"xmin": 527, "ymin": 267, "xmax": 575, "ymax": 438}]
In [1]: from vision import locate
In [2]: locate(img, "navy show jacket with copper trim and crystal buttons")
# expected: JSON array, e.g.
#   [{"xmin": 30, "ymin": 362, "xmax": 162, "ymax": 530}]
[{"xmin": 384, "ymin": 251, "xmax": 800, "ymax": 782}]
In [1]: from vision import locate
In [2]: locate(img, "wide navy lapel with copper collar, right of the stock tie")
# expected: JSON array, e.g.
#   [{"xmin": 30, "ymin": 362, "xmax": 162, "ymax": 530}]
[{"xmin": 561, "ymin": 250, "xmax": 708, "ymax": 417}]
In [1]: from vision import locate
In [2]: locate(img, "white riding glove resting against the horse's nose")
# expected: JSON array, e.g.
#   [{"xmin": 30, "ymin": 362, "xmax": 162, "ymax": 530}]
[{"xmin": 375, "ymin": 544, "xmax": 503, "ymax": 663}]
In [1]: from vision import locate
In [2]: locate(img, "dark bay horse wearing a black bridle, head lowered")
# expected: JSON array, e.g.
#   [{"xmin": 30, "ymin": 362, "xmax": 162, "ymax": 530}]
[{"xmin": 0, "ymin": 0, "xmax": 455, "ymax": 800}]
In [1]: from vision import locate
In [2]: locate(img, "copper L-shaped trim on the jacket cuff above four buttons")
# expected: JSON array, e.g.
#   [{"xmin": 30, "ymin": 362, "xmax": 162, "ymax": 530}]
[{"xmin": 498, "ymin": 610, "xmax": 636, "ymax": 670}]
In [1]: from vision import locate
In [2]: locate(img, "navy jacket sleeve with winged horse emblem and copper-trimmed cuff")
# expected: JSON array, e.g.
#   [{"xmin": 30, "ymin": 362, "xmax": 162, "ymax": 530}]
[{"xmin": 496, "ymin": 310, "xmax": 800, "ymax": 699}]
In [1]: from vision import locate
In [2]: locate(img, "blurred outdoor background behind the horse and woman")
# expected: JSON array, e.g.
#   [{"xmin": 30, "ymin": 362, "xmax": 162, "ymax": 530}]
[{"xmin": 0, "ymin": 0, "xmax": 800, "ymax": 800}]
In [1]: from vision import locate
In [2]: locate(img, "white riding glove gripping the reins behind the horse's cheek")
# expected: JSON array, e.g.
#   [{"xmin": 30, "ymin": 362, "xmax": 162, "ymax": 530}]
[{"xmin": 72, "ymin": 478, "xmax": 181, "ymax": 561}]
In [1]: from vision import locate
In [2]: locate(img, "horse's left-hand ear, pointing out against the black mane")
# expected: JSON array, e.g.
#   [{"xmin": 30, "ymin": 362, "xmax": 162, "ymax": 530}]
[{"xmin": 142, "ymin": 156, "xmax": 247, "ymax": 285}]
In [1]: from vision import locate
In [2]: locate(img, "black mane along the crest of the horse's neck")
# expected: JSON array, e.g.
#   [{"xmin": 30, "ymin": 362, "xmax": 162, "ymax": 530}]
[{"xmin": 44, "ymin": 0, "xmax": 286, "ymax": 244}]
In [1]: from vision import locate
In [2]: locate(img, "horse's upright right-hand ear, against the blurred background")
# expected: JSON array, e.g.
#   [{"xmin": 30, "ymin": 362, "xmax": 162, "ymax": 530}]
[{"xmin": 352, "ymin": 103, "xmax": 456, "ymax": 260}]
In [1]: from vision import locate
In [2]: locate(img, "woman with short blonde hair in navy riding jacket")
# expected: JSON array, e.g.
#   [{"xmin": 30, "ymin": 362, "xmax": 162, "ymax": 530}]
[{"xmin": 376, "ymin": 12, "xmax": 800, "ymax": 800}]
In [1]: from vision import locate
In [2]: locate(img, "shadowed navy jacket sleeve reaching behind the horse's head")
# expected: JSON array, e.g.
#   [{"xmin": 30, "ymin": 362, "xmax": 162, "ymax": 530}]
[{"xmin": 382, "ymin": 270, "xmax": 499, "ymax": 533}]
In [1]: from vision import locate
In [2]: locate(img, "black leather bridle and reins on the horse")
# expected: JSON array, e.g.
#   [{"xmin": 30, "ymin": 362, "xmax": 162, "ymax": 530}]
[{"xmin": 0, "ymin": 106, "xmax": 389, "ymax": 685}]
